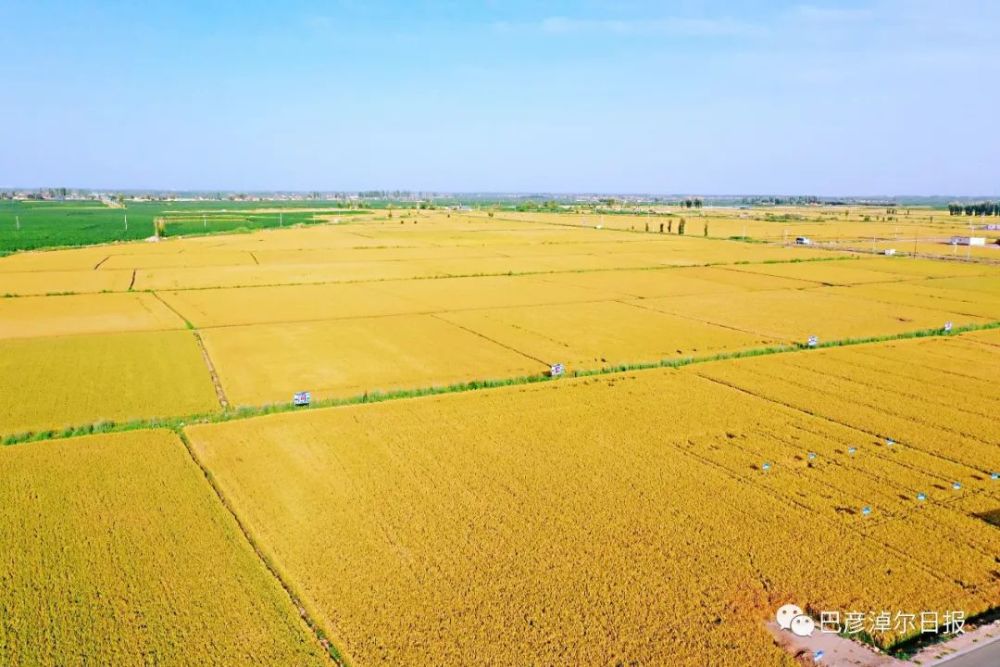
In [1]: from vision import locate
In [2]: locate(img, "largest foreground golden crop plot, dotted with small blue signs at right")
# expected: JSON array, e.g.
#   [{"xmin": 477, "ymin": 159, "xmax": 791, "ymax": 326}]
[{"xmin": 187, "ymin": 341, "xmax": 1000, "ymax": 665}]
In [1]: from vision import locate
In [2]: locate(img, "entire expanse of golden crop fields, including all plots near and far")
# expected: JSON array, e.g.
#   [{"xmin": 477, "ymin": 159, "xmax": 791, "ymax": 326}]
[{"xmin": 0, "ymin": 207, "xmax": 1000, "ymax": 667}]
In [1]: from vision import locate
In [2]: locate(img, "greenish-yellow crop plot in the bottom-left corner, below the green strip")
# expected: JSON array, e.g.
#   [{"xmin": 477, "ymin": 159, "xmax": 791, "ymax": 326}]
[{"xmin": 0, "ymin": 431, "xmax": 325, "ymax": 665}]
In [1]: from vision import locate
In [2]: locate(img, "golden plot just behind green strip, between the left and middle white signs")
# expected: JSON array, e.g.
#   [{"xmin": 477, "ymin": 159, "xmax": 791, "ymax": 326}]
[{"xmin": 203, "ymin": 315, "xmax": 547, "ymax": 405}]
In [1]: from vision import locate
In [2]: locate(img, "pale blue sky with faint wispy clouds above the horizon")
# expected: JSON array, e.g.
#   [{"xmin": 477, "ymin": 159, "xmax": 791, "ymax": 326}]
[{"xmin": 0, "ymin": 0, "xmax": 1000, "ymax": 195}]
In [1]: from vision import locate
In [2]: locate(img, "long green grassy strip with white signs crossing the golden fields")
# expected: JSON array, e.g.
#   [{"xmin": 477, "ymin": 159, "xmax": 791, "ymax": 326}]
[{"xmin": 2, "ymin": 321, "xmax": 1000, "ymax": 445}]
